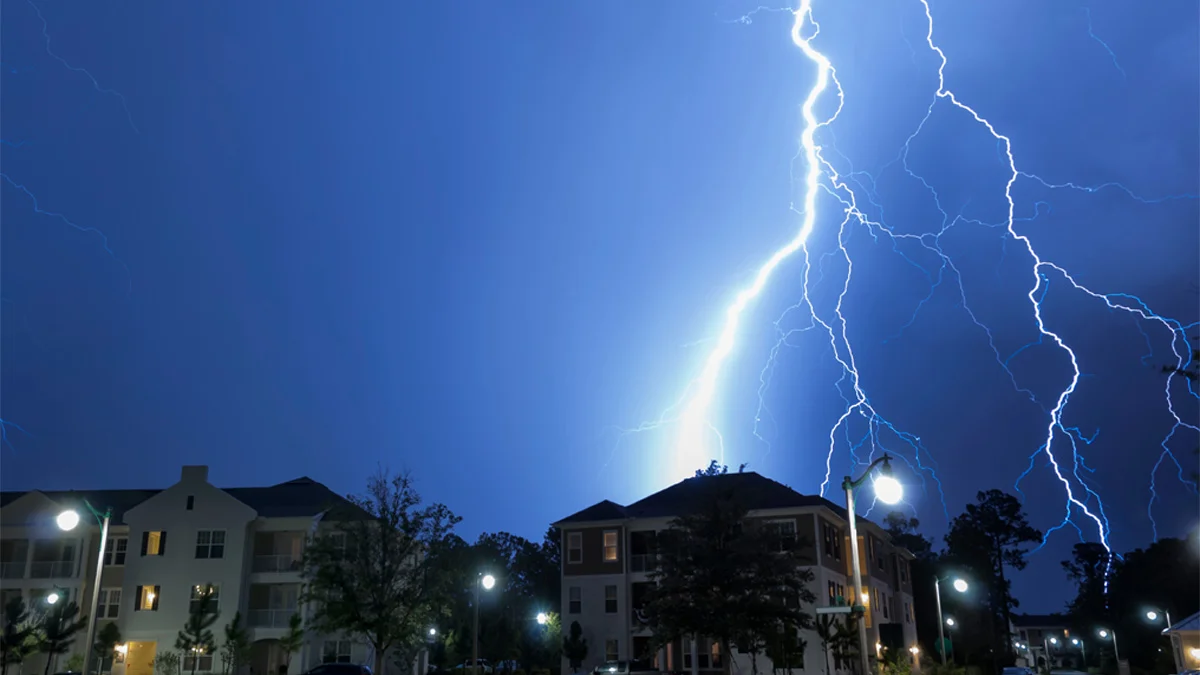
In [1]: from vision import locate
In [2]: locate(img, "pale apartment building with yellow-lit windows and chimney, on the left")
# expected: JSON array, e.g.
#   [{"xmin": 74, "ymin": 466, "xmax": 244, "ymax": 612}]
[{"xmin": 0, "ymin": 466, "xmax": 382, "ymax": 675}]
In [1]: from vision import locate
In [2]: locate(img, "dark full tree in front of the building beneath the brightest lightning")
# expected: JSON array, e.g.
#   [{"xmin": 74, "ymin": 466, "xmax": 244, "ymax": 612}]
[{"xmin": 644, "ymin": 474, "xmax": 816, "ymax": 668}]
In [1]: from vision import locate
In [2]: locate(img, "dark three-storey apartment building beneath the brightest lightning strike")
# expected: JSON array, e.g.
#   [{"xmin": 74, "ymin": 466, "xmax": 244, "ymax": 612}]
[{"xmin": 554, "ymin": 472, "xmax": 917, "ymax": 674}]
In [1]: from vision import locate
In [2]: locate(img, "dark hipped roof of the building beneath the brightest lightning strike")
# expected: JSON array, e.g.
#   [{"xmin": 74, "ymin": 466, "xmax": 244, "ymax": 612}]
[{"xmin": 558, "ymin": 471, "xmax": 863, "ymax": 525}]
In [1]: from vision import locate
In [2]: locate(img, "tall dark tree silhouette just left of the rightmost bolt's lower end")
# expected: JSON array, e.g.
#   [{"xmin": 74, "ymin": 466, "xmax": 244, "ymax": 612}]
[{"xmin": 946, "ymin": 490, "xmax": 1042, "ymax": 664}]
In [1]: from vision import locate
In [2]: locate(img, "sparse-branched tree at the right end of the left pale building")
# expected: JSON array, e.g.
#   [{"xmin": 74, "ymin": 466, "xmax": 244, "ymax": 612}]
[{"xmin": 302, "ymin": 472, "xmax": 460, "ymax": 673}]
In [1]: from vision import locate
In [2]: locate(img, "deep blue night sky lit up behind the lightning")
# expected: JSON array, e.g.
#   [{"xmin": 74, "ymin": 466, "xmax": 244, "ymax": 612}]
[{"xmin": 0, "ymin": 0, "xmax": 1200, "ymax": 611}]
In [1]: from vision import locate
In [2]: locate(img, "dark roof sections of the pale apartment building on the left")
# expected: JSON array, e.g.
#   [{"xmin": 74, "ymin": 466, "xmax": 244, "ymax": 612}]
[{"xmin": 0, "ymin": 476, "xmax": 365, "ymax": 522}]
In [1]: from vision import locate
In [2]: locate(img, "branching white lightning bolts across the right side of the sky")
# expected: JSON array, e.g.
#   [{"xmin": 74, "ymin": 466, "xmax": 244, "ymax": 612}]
[{"xmin": 655, "ymin": 0, "xmax": 1200, "ymax": 560}]
